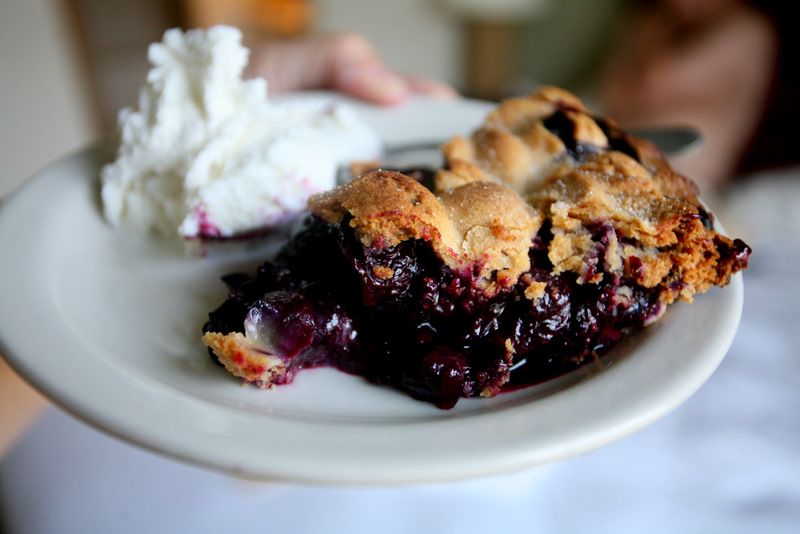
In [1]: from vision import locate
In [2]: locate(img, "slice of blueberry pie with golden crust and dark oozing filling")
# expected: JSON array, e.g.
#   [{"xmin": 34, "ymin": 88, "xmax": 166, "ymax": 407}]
[{"xmin": 203, "ymin": 87, "xmax": 750, "ymax": 408}]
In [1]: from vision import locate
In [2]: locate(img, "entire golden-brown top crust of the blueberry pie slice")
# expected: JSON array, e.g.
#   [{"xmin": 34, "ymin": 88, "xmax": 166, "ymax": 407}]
[{"xmin": 309, "ymin": 87, "xmax": 746, "ymax": 302}]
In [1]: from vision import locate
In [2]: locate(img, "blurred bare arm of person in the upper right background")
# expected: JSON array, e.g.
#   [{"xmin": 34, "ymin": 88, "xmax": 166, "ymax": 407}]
[{"xmin": 600, "ymin": 0, "xmax": 778, "ymax": 192}]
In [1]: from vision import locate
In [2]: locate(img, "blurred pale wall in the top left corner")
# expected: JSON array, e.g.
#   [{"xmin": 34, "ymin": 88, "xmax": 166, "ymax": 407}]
[{"xmin": 0, "ymin": 0, "xmax": 95, "ymax": 197}]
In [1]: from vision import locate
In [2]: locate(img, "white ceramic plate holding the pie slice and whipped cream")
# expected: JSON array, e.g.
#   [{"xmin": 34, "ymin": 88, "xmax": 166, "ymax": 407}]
[{"xmin": 0, "ymin": 95, "xmax": 742, "ymax": 484}]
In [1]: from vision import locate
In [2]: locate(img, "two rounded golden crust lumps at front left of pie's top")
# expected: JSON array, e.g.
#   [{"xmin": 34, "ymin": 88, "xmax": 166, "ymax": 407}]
[{"xmin": 309, "ymin": 171, "xmax": 544, "ymax": 292}]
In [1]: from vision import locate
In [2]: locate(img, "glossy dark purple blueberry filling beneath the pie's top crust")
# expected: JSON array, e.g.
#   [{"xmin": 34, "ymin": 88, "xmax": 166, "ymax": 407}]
[{"xmin": 204, "ymin": 216, "xmax": 663, "ymax": 408}]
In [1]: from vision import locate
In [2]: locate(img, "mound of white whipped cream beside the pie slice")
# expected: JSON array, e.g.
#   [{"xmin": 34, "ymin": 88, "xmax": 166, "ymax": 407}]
[{"xmin": 101, "ymin": 26, "xmax": 382, "ymax": 239}]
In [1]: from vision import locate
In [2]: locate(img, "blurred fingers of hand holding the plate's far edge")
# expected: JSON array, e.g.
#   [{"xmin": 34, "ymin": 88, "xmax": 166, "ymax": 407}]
[{"xmin": 248, "ymin": 33, "xmax": 458, "ymax": 105}]
